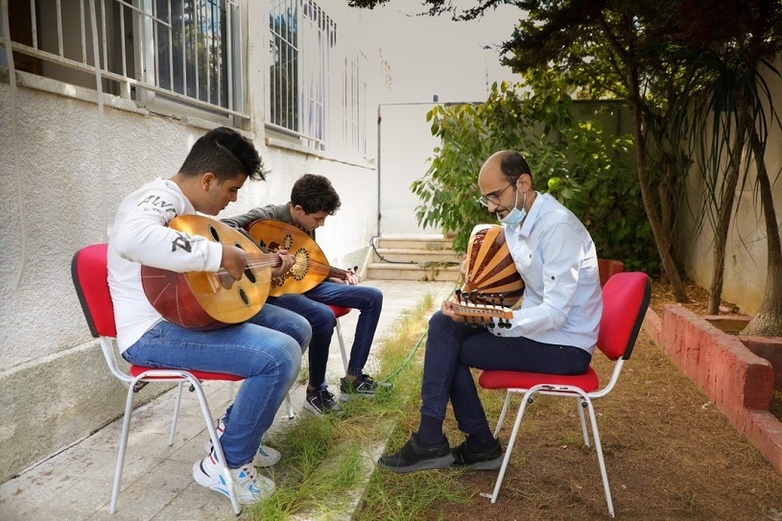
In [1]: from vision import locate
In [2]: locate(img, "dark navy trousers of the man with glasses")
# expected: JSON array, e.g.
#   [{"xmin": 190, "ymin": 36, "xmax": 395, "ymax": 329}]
[{"xmin": 421, "ymin": 311, "xmax": 592, "ymax": 435}]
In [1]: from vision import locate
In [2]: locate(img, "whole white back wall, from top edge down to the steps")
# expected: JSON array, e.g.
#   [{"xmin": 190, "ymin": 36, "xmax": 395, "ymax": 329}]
[{"xmin": 358, "ymin": 0, "xmax": 522, "ymax": 234}]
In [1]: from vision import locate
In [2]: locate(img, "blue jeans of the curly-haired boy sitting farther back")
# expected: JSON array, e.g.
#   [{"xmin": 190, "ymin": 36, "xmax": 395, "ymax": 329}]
[{"xmin": 269, "ymin": 281, "xmax": 383, "ymax": 389}]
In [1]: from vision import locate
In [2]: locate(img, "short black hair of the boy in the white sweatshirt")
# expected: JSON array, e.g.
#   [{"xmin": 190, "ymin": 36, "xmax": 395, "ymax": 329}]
[{"xmin": 179, "ymin": 127, "xmax": 266, "ymax": 182}]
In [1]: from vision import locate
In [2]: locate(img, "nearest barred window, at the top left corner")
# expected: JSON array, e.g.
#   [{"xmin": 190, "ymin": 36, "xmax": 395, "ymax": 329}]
[{"xmin": 1, "ymin": 0, "xmax": 246, "ymax": 123}]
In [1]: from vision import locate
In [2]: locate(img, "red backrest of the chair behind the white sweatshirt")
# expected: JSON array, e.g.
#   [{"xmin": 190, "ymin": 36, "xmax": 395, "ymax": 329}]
[{"xmin": 71, "ymin": 243, "xmax": 117, "ymax": 338}]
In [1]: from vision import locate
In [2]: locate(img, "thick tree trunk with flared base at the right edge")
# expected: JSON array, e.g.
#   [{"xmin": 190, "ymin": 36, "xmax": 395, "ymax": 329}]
[{"xmin": 741, "ymin": 124, "xmax": 782, "ymax": 336}]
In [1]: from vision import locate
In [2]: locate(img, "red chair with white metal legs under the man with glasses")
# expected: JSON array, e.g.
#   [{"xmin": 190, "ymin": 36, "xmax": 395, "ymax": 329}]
[{"xmin": 478, "ymin": 272, "xmax": 652, "ymax": 517}]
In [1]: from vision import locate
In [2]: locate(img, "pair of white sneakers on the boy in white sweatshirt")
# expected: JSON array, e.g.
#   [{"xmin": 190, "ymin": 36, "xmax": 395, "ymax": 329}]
[{"xmin": 193, "ymin": 453, "xmax": 275, "ymax": 505}]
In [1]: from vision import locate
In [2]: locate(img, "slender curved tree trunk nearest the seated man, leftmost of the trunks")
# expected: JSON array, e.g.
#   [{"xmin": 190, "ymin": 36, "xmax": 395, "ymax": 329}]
[{"xmin": 629, "ymin": 71, "xmax": 690, "ymax": 302}]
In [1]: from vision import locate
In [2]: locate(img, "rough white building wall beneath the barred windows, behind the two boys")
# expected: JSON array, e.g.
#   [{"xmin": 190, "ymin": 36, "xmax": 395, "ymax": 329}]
[{"xmin": 0, "ymin": 0, "xmax": 378, "ymax": 482}]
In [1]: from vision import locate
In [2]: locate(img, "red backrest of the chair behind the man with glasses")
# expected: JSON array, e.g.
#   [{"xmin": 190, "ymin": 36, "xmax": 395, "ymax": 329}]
[{"xmin": 597, "ymin": 271, "xmax": 652, "ymax": 360}]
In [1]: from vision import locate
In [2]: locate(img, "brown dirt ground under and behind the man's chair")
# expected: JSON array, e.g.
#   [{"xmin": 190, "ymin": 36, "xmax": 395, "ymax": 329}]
[{"xmin": 433, "ymin": 282, "xmax": 782, "ymax": 521}]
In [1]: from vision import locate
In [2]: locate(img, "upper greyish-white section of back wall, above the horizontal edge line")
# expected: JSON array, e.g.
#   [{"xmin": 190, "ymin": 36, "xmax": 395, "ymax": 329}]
[{"xmin": 360, "ymin": 0, "xmax": 523, "ymax": 104}]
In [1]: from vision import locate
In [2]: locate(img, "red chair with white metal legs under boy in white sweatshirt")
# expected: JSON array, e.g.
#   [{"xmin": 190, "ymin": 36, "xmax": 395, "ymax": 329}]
[{"xmin": 71, "ymin": 243, "xmax": 247, "ymax": 515}]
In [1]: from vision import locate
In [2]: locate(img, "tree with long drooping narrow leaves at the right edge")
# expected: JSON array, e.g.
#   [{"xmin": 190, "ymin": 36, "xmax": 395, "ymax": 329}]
[{"xmin": 668, "ymin": 0, "xmax": 782, "ymax": 336}]
